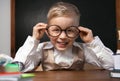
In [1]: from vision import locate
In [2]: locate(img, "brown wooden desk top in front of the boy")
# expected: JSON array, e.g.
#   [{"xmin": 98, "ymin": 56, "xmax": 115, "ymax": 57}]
[{"xmin": 33, "ymin": 70, "xmax": 120, "ymax": 81}]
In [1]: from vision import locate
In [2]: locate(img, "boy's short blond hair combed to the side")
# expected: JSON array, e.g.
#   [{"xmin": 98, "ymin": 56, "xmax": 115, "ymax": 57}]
[{"xmin": 47, "ymin": 2, "xmax": 80, "ymax": 22}]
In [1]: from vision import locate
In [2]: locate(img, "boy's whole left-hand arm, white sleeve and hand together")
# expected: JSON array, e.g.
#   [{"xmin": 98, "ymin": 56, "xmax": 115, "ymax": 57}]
[{"xmin": 14, "ymin": 23, "xmax": 47, "ymax": 71}]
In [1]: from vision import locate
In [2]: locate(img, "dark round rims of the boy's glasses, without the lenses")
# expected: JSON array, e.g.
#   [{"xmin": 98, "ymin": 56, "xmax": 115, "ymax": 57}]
[{"xmin": 46, "ymin": 25, "xmax": 80, "ymax": 38}]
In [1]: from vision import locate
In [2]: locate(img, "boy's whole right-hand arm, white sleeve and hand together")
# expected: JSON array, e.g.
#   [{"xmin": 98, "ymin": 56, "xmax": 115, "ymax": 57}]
[{"xmin": 79, "ymin": 27, "xmax": 113, "ymax": 69}]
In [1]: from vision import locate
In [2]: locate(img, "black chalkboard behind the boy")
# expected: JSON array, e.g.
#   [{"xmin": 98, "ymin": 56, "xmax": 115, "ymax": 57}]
[{"xmin": 15, "ymin": 0, "xmax": 117, "ymax": 52}]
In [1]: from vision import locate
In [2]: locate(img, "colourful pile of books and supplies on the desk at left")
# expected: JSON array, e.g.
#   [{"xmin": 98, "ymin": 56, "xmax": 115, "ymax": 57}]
[{"xmin": 0, "ymin": 54, "xmax": 35, "ymax": 81}]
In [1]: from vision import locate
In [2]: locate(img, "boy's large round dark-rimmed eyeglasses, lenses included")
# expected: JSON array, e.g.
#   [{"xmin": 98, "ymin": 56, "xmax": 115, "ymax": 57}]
[{"xmin": 46, "ymin": 25, "xmax": 80, "ymax": 38}]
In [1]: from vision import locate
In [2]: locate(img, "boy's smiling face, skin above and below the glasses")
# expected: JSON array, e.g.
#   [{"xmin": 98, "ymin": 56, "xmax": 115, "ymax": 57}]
[{"xmin": 47, "ymin": 17, "xmax": 79, "ymax": 51}]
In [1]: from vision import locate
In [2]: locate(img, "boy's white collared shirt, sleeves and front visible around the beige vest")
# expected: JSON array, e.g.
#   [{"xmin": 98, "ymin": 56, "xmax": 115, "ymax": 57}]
[{"xmin": 14, "ymin": 36, "xmax": 114, "ymax": 72}]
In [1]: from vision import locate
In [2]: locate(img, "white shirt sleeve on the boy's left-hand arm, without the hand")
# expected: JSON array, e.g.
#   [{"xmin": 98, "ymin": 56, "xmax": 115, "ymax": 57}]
[{"xmin": 14, "ymin": 36, "xmax": 42, "ymax": 71}]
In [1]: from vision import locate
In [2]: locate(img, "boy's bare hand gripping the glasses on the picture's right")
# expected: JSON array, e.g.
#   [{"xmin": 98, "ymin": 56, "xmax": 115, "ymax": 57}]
[{"xmin": 79, "ymin": 26, "xmax": 94, "ymax": 43}]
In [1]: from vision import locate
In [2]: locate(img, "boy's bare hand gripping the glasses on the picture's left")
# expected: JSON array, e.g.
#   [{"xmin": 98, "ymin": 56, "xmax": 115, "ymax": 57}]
[{"xmin": 32, "ymin": 23, "xmax": 47, "ymax": 40}]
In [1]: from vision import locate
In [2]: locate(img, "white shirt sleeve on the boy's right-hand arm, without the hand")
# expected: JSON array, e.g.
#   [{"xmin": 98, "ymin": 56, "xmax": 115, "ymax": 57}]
[{"xmin": 84, "ymin": 37, "xmax": 114, "ymax": 70}]
